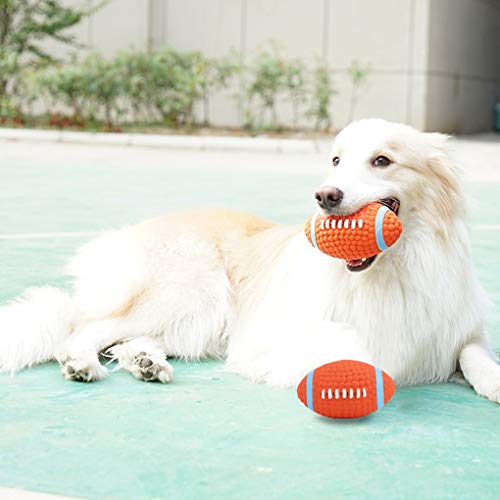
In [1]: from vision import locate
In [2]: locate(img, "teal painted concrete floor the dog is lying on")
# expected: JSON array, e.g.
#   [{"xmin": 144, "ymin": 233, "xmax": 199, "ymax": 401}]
[{"xmin": 0, "ymin": 143, "xmax": 500, "ymax": 499}]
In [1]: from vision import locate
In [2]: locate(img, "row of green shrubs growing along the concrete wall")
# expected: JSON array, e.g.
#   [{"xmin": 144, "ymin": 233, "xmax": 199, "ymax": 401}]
[{"xmin": 5, "ymin": 42, "xmax": 350, "ymax": 131}]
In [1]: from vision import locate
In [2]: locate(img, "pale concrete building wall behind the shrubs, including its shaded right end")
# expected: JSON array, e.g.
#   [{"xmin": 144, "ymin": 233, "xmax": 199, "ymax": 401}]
[{"xmin": 47, "ymin": 0, "xmax": 500, "ymax": 132}]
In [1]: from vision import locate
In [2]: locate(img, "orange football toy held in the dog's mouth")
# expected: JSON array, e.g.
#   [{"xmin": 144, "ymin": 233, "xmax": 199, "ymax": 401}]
[{"xmin": 305, "ymin": 201, "xmax": 403, "ymax": 267}]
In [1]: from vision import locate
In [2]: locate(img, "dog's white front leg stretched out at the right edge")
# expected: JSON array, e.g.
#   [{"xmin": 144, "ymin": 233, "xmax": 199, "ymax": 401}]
[{"xmin": 459, "ymin": 337, "xmax": 500, "ymax": 403}]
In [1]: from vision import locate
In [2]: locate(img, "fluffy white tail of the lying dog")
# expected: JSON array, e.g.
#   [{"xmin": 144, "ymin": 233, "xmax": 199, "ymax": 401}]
[{"xmin": 0, "ymin": 287, "xmax": 76, "ymax": 373}]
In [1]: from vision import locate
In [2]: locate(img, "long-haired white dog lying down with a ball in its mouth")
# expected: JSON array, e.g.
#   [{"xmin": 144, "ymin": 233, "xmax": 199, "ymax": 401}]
[{"xmin": 0, "ymin": 120, "xmax": 500, "ymax": 402}]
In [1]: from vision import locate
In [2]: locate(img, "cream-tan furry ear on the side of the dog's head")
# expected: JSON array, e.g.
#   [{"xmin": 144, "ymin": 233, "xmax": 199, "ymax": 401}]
[{"xmin": 425, "ymin": 133, "xmax": 466, "ymax": 232}]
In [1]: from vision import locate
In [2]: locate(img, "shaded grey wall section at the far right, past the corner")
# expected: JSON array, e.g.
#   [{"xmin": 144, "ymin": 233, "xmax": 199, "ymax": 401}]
[{"xmin": 426, "ymin": 0, "xmax": 500, "ymax": 133}]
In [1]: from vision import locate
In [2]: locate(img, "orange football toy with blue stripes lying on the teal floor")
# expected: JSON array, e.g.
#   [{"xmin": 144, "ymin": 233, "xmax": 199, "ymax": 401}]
[{"xmin": 297, "ymin": 359, "xmax": 396, "ymax": 418}]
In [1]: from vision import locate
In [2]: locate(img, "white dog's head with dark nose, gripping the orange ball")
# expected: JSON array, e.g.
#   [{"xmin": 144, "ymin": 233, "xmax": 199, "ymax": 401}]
[{"xmin": 315, "ymin": 119, "xmax": 464, "ymax": 271}]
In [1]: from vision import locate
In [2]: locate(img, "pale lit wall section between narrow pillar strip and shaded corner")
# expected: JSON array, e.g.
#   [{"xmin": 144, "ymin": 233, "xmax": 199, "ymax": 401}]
[{"xmin": 146, "ymin": 0, "xmax": 428, "ymax": 127}]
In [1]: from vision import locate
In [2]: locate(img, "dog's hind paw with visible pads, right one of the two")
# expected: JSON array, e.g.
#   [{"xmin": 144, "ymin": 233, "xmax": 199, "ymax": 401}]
[{"xmin": 106, "ymin": 337, "xmax": 174, "ymax": 384}]
